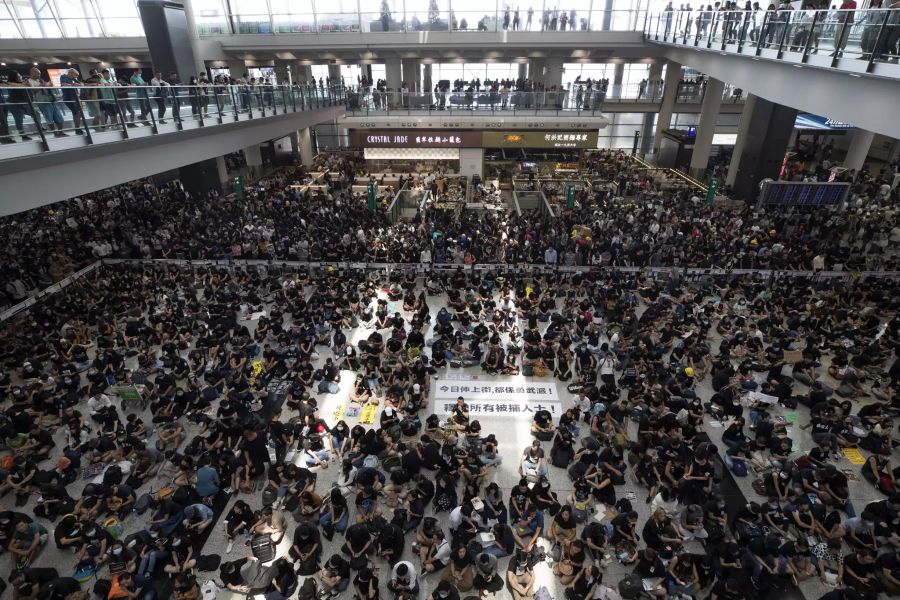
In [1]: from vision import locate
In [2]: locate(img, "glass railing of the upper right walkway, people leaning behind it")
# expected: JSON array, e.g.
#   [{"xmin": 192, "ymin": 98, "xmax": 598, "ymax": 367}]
[{"xmin": 644, "ymin": 8, "xmax": 900, "ymax": 71}]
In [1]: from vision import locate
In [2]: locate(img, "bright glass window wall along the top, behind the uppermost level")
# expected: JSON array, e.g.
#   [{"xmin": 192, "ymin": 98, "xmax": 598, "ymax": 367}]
[{"xmin": 0, "ymin": 0, "xmax": 652, "ymax": 39}]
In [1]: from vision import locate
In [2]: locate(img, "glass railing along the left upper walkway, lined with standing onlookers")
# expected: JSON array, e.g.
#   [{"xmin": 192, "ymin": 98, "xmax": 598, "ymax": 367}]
[{"xmin": 0, "ymin": 84, "xmax": 346, "ymax": 160}]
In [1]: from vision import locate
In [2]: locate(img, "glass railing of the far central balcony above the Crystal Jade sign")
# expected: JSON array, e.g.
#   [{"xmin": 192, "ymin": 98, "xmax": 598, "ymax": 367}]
[{"xmin": 347, "ymin": 80, "xmax": 744, "ymax": 116}]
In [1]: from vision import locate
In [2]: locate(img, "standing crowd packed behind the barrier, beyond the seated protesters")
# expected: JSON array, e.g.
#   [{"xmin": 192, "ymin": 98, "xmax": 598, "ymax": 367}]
[{"xmin": 0, "ymin": 151, "xmax": 900, "ymax": 312}]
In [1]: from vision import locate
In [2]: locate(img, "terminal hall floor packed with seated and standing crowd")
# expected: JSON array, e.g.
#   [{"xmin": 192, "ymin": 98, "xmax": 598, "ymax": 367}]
[{"xmin": 0, "ymin": 142, "xmax": 900, "ymax": 600}]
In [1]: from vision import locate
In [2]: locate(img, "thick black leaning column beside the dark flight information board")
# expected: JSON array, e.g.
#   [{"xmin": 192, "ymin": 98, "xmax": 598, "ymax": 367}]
[{"xmin": 724, "ymin": 89, "xmax": 797, "ymax": 201}]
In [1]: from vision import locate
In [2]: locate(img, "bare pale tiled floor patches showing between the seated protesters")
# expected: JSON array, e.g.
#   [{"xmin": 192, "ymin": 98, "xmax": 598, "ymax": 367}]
[{"xmin": 10, "ymin": 274, "xmax": 896, "ymax": 600}]
